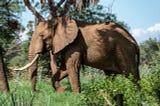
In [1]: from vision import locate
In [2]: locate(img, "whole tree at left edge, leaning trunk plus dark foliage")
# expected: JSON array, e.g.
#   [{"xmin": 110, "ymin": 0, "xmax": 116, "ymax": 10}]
[{"xmin": 0, "ymin": 0, "xmax": 22, "ymax": 91}]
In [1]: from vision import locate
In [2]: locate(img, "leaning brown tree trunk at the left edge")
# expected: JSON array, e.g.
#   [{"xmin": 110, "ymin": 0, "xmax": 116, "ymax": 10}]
[{"xmin": 0, "ymin": 47, "xmax": 9, "ymax": 92}]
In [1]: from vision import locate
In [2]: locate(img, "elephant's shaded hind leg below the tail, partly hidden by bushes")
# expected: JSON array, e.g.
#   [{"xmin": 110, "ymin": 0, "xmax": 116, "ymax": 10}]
[{"xmin": 117, "ymin": 49, "xmax": 140, "ymax": 89}]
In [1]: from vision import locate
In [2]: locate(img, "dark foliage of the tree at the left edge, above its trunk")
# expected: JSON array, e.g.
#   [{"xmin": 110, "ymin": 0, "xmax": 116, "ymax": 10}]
[{"xmin": 0, "ymin": 0, "xmax": 23, "ymax": 50}]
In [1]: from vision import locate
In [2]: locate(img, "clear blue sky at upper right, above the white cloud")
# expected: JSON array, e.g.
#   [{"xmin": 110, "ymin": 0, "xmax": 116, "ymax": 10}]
[{"xmin": 100, "ymin": 0, "xmax": 160, "ymax": 28}]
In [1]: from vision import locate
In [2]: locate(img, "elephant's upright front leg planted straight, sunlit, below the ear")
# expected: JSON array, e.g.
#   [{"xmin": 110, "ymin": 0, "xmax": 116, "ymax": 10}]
[{"xmin": 66, "ymin": 52, "xmax": 80, "ymax": 92}]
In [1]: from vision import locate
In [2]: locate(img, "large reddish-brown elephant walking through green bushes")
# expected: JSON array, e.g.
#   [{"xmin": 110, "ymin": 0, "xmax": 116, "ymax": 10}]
[{"xmin": 15, "ymin": 17, "xmax": 140, "ymax": 92}]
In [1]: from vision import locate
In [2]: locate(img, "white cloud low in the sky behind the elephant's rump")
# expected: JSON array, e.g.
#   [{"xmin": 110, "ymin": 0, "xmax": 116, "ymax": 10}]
[{"xmin": 131, "ymin": 23, "xmax": 160, "ymax": 43}]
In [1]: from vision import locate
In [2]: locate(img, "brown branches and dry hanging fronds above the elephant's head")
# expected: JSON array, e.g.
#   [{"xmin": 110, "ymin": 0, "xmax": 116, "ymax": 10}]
[{"xmin": 24, "ymin": 0, "xmax": 99, "ymax": 21}]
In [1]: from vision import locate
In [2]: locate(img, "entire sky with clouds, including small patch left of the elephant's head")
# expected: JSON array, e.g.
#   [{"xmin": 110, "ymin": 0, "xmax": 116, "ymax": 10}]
[{"xmin": 22, "ymin": 0, "xmax": 160, "ymax": 43}]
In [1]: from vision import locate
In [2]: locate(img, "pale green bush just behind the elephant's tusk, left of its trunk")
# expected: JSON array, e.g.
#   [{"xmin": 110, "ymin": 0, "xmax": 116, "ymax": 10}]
[{"xmin": 5, "ymin": 40, "xmax": 29, "ymax": 67}]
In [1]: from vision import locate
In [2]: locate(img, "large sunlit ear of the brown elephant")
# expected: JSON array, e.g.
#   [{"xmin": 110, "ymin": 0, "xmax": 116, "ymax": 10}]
[{"xmin": 53, "ymin": 18, "xmax": 78, "ymax": 53}]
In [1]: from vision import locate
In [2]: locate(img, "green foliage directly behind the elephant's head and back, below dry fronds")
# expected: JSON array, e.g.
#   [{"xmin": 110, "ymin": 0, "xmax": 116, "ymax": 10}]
[{"xmin": 31, "ymin": 2, "xmax": 130, "ymax": 30}]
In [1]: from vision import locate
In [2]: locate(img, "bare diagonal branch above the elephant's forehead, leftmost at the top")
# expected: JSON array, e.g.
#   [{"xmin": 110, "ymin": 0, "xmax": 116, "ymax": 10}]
[{"xmin": 24, "ymin": 0, "xmax": 44, "ymax": 21}]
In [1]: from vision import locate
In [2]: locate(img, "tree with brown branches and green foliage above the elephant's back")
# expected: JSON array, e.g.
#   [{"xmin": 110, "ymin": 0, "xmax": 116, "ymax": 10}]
[{"xmin": 24, "ymin": 0, "xmax": 129, "ymax": 30}]
